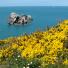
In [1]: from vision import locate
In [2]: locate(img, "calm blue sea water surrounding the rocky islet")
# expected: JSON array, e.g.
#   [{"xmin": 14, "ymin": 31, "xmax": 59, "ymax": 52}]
[{"xmin": 0, "ymin": 6, "xmax": 68, "ymax": 39}]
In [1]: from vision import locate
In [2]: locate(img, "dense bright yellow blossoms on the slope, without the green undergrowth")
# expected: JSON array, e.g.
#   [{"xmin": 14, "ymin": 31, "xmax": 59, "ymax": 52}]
[{"xmin": 0, "ymin": 20, "xmax": 68, "ymax": 64}]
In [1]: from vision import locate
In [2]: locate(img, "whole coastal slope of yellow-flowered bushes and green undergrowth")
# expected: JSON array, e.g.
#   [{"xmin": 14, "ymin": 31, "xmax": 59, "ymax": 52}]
[{"xmin": 0, "ymin": 20, "xmax": 68, "ymax": 68}]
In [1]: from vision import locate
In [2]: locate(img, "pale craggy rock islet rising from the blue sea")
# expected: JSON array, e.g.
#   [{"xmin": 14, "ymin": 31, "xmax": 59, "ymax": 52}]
[{"xmin": 9, "ymin": 12, "xmax": 32, "ymax": 24}]
